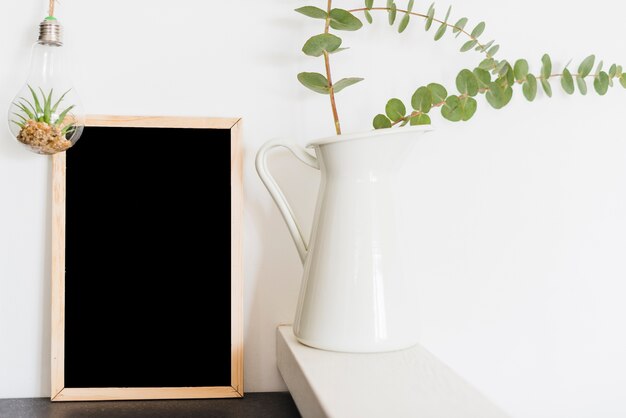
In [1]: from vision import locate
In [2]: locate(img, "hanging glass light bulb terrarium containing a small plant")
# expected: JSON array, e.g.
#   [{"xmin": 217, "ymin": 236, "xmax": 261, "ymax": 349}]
[{"xmin": 9, "ymin": 17, "xmax": 85, "ymax": 155}]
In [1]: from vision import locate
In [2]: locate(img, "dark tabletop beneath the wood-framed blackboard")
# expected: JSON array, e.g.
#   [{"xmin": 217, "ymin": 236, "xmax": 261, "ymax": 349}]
[{"xmin": 0, "ymin": 392, "xmax": 300, "ymax": 418}]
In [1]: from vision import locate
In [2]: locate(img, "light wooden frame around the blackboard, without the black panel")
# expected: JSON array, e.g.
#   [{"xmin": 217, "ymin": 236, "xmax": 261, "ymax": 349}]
[{"xmin": 51, "ymin": 116, "xmax": 244, "ymax": 401}]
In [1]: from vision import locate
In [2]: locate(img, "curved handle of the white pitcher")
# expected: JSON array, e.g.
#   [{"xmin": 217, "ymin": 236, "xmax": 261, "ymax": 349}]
[{"xmin": 256, "ymin": 139, "xmax": 320, "ymax": 264}]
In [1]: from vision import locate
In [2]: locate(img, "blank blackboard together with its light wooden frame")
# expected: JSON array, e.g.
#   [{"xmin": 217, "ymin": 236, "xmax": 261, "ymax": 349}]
[{"xmin": 51, "ymin": 116, "xmax": 243, "ymax": 401}]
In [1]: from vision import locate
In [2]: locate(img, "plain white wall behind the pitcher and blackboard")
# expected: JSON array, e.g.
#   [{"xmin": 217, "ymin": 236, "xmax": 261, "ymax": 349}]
[{"xmin": 0, "ymin": 0, "xmax": 626, "ymax": 418}]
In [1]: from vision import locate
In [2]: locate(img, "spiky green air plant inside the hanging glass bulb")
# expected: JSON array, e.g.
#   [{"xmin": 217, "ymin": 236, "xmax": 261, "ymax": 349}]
[{"xmin": 11, "ymin": 85, "xmax": 76, "ymax": 136}]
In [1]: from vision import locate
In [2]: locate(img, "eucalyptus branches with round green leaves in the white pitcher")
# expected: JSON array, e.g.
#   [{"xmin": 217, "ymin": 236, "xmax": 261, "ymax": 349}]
[{"xmin": 296, "ymin": 0, "xmax": 626, "ymax": 135}]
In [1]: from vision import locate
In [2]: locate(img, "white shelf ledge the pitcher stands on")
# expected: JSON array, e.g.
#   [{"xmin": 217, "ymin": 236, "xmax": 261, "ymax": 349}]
[{"xmin": 276, "ymin": 326, "xmax": 508, "ymax": 418}]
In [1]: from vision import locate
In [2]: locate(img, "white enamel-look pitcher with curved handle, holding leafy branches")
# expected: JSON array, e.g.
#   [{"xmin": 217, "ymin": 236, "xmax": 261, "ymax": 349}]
[{"xmin": 256, "ymin": 127, "xmax": 429, "ymax": 353}]
